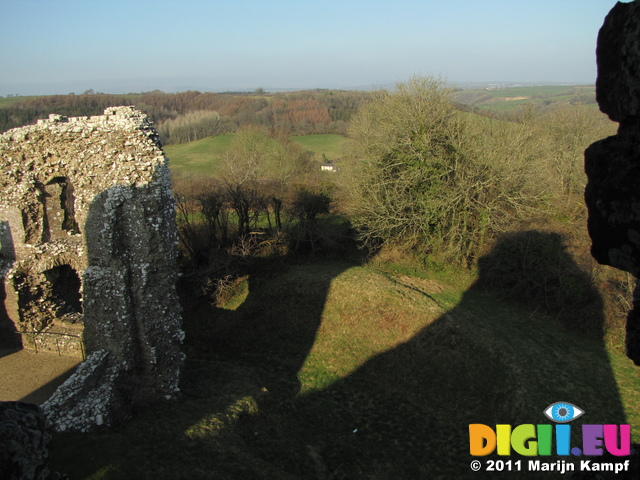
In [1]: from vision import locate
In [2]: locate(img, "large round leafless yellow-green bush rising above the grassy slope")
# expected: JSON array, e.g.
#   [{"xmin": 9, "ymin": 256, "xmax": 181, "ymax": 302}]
[{"xmin": 347, "ymin": 77, "xmax": 545, "ymax": 265}]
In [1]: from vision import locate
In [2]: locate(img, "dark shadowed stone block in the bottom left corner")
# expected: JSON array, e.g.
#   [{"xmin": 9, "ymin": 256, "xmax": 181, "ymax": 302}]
[{"xmin": 0, "ymin": 402, "xmax": 51, "ymax": 480}]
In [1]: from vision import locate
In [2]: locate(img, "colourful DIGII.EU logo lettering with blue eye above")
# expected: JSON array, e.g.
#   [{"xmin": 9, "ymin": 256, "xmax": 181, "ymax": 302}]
[{"xmin": 469, "ymin": 402, "xmax": 631, "ymax": 457}]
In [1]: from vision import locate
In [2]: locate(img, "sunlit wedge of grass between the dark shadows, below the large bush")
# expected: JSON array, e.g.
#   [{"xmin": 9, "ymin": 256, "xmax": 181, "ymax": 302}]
[{"xmin": 298, "ymin": 266, "xmax": 443, "ymax": 395}]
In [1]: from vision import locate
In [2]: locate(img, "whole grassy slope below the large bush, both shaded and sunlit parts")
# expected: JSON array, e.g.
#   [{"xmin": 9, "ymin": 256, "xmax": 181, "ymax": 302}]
[{"xmin": 53, "ymin": 262, "xmax": 640, "ymax": 479}]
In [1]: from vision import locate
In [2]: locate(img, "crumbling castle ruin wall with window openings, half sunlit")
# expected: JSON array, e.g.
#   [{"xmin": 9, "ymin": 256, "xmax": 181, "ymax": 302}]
[{"xmin": 0, "ymin": 107, "xmax": 184, "ymax": 431}]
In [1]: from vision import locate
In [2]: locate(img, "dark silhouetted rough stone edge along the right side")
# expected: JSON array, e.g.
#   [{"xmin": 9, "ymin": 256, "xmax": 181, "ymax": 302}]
[{"xmin": 585, "ymin": 0, "xmax": 640, "ymax": 365}]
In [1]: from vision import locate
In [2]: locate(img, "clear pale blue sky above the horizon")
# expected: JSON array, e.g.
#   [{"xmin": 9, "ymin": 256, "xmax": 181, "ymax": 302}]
[{"xmin": 0, "ymin": 0, "xmax": 632, "ymax": 95}]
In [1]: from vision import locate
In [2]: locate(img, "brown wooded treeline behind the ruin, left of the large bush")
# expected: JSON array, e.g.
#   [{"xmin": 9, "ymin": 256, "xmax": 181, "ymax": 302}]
[{"xmin": 0, "ymin": 90, "xmax": 370, "ymax": 144}]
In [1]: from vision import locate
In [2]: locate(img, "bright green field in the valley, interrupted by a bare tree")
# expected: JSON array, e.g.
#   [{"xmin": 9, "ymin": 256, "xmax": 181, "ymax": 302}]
[{"xmin": 163, "ymin": 133, "xmax": 350, "ymax": 177}]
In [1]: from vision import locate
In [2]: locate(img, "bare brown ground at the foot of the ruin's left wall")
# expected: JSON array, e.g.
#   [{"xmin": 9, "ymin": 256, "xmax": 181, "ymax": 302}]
[{"xmin": 0, "ymin": 350, "xmax": 81, "ymax": 405}]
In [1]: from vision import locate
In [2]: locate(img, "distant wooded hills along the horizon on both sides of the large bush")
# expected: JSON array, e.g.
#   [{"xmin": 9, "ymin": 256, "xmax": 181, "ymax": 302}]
[{"xmin": 0, "ymin": 85, "xmax": 597, "ymax": 145}]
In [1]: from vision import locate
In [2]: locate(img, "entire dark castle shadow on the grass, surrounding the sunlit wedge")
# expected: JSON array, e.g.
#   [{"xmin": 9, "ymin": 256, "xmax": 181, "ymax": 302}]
[{"xmin": 54, "ymin": 232, "xmax": 625, "ymax": 480}]
